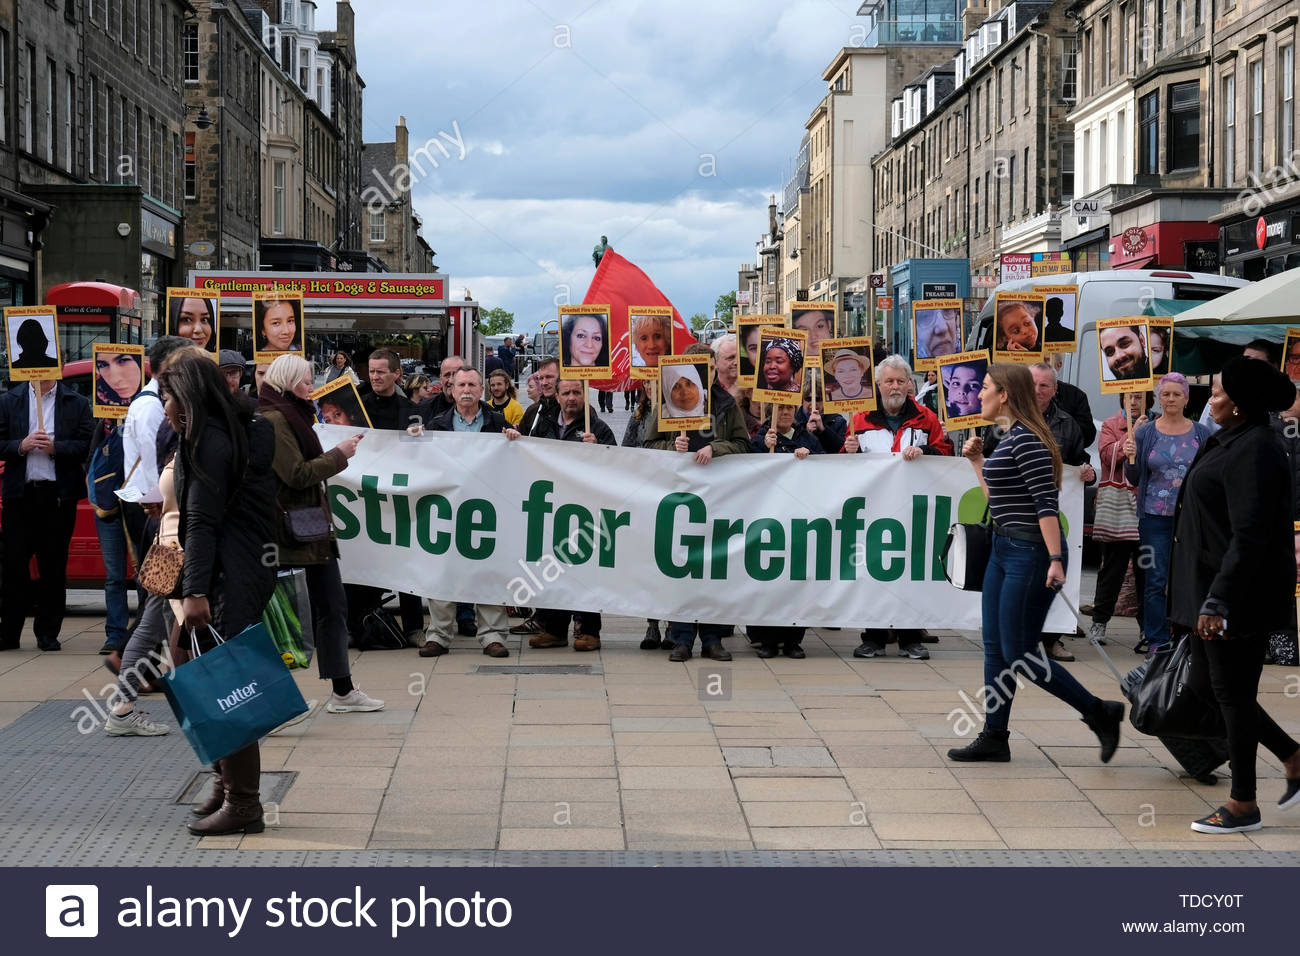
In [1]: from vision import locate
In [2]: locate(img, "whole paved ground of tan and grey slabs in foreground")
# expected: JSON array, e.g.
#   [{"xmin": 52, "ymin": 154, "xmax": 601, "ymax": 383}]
[{"xmin": 0, "ymin": 580, "xmax": 1300, "ymax": 866}]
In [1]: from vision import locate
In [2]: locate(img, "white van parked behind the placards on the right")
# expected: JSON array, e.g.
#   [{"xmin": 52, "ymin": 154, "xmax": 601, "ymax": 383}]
[{"xmin": 966, "ymin": 269, "xmax": 1248, "ymax": 442}]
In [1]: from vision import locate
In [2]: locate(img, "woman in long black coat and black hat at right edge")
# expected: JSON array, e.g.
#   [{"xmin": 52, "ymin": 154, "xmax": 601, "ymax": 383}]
[{"xmin": 1169, "ymin": 358, "xmax": 1300, "ymax": 834}]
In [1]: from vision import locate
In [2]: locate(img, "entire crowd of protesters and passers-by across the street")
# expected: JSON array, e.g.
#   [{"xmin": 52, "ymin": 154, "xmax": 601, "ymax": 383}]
[{"xmin": 0, "ymin": 325, "xmax": 1300, "ymax": 835}]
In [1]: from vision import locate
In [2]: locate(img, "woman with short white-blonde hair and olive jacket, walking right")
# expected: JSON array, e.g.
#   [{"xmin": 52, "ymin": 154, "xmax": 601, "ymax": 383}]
[{"xmin": 257, "ymin": 355, "xmax": 384, "ymax": 714}]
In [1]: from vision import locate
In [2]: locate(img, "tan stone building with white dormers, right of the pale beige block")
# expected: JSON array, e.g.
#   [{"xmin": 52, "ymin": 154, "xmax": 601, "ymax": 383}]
[{"xmin": 872, "ymin": 3, "xmax": 1074, "ymax": 277}]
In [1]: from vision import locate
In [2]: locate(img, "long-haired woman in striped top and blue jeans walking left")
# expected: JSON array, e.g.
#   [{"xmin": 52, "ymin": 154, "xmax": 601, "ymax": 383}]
[{"xmin": 948, "ymin": 364, "xmax": 1125, "ymax": 763}]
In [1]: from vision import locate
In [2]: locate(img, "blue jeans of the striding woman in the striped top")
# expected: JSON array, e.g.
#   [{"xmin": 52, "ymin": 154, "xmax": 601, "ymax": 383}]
[{"xmin": 983, "ymin": 535, "xmax": 1097, "ymax": 731}]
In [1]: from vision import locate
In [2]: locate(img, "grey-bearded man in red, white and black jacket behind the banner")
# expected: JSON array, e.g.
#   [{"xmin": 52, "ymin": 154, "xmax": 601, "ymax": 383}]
[{"xmin": 844, "ymin": 355, "xmax": 953, "ymax": 661}]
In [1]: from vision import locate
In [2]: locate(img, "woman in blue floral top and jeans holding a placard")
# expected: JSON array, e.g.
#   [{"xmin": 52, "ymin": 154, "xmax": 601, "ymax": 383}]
[{"xmin": 1123, "ymin": 372, "xmax": 1210, "ymax": 652}]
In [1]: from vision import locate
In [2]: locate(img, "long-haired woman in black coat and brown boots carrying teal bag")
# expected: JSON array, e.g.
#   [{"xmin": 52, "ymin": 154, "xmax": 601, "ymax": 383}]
[{"xmin": 159, "ymin": 360, "xmax": 276, "ymax": 836}]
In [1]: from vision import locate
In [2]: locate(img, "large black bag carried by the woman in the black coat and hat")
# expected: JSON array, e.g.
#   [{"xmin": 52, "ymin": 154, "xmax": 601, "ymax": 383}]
[{"xmin": 1123, "ymin": 637, "xmax": 1227, "ymax": 740}]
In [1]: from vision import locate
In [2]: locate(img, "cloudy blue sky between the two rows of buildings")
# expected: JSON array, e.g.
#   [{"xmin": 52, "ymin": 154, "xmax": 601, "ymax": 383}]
[{"xmin": 317, "ymin": 0, "xmax": 862, "ymax": 332}]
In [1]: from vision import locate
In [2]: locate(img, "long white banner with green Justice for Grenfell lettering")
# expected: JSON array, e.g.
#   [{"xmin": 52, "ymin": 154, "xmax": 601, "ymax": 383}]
[{"xmin": 325, "ymin": 425, "xmax": 1083, "ymax": 633}]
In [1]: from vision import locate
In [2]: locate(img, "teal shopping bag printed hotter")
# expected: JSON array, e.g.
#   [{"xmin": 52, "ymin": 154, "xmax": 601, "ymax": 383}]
[{"xmin": 163, "ymin": 623, "xmax": 307, "ymax": 763}]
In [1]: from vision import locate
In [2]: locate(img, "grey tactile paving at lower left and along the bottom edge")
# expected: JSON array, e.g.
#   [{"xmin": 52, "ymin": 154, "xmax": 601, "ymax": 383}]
[{"xmin": 0, "ymin": 702, "xmax": 1300, "ymax": 868}]
